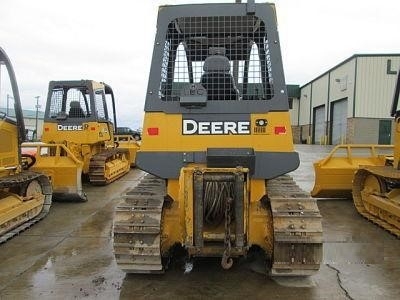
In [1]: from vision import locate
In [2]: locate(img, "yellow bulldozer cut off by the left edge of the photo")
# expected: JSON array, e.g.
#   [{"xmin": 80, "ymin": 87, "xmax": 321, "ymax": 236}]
[{"xmin": 0, "ymin": 48, "xmax": 52, "ymax": 243}]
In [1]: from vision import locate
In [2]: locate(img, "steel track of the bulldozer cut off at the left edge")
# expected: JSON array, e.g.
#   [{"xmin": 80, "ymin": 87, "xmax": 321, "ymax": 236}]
[{"xmin": 0, "ymin": 171, "xmax": 52, "ymax": 244}]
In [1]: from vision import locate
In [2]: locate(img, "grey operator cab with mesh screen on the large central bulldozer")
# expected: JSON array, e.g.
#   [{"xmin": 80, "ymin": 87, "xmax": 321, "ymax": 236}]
[{"xmin": 145, "ymin": 10, "xmax": 288, "ymax": 114}]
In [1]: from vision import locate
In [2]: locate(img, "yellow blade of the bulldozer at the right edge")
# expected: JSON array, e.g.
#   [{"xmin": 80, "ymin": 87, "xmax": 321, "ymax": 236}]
[{"xmin": 311, "ymin": 144, "xmax": 393, "ymax": 198}]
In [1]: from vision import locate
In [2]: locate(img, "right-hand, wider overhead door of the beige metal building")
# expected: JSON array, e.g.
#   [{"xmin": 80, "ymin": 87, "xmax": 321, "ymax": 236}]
[{"xmin": 331, "ymin": 99, "xmax": 347, "ymax": 145}]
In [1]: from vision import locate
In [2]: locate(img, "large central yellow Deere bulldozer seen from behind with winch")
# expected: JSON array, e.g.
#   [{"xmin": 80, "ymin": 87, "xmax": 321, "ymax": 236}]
[{"xmin": 113, "ymin": 1, "xmax": 322, "ymax": 276}]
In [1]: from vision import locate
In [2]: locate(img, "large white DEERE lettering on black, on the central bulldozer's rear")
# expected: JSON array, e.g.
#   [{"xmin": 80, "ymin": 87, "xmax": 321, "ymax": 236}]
[{"xmin": 182, "ymin": 119, "xmax": 250, "ymax": 135}]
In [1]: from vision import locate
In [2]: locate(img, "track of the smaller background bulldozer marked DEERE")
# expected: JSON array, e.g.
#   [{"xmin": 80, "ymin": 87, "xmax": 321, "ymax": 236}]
[{"xmin": 89, "ymin": 149, "xmax": 130, "ymax": 185}]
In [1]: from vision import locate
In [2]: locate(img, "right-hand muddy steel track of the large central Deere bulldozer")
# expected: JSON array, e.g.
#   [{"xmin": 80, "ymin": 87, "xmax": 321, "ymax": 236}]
[{"xmin": 267, "ymin": 175, "xmax": 322, "ymax": 276}]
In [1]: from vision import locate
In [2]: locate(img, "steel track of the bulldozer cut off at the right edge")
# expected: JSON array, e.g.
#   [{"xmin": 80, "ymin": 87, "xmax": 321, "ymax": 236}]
[{"xmin": 353, "ymin": 166, "xmax": 400, "ymax": 238}]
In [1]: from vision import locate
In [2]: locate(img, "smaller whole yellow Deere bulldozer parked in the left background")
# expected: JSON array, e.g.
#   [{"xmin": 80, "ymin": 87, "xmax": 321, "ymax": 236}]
[{"xmin": 24, "ymin": 80, "xmax": 130, "ymax": 201}]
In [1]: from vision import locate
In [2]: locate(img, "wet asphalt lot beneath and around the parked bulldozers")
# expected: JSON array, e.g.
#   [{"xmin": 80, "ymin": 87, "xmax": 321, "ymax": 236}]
[{"xmin": 0, "ymin": 145, "xmax": 400, "ymax": 300}]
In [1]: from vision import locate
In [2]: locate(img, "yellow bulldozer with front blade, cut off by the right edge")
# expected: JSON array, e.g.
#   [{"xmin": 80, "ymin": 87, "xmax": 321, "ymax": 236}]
[{"xmin": 311, "ymin": 71, "xmax": 400, "ymax": 237}]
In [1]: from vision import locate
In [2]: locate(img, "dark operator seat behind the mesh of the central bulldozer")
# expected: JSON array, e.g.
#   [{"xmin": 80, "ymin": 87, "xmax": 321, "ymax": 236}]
[{"xmin": 200, "ymin": 54, "xmax": 239, "ymax": 100}]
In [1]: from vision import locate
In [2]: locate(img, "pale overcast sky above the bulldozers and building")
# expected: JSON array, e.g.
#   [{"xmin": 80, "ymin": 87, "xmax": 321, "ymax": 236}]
[{"xmin": 0, "ymin": 0, "xmax": 400, "ymax": 128}]
